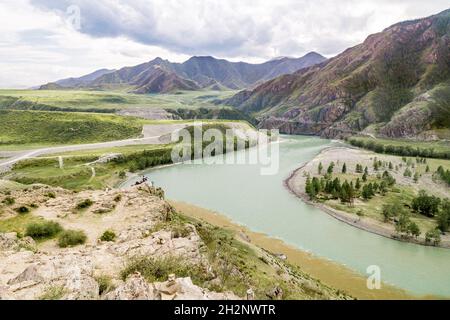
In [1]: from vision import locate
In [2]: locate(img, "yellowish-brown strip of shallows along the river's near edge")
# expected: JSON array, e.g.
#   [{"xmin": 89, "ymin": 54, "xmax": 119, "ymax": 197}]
[{"xmin": 169, "ymin": 201, "xmax": 420, "ymax": 300}]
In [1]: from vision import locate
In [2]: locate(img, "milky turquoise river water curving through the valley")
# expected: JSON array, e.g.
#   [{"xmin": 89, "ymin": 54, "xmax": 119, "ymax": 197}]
[{"xmin": 123, "ymin": 136, "xmax": 450, "ymax": 297}]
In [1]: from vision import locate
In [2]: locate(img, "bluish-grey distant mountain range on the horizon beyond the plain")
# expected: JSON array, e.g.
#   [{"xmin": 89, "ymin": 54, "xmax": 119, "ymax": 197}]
[{"xmin": 43, "ymin": 52, "xmax": 326, "ymax": 93}]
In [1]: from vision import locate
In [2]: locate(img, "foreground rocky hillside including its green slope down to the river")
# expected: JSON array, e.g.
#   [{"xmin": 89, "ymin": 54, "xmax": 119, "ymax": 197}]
[{"xmin": 0, "ymin": 185, "xmax": 348, "ymax": 300}]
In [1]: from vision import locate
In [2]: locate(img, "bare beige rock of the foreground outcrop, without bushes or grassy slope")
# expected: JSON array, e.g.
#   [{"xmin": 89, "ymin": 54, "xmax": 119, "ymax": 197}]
[{"xmin": 0, "ymin": 185, "xmax": 238, "ymax": 300}]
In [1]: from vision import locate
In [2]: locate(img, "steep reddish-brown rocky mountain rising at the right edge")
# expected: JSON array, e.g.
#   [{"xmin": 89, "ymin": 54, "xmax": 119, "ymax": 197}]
[{"xmin": 224, "ymin": 10, "xmax": 450, "ymax": 137}]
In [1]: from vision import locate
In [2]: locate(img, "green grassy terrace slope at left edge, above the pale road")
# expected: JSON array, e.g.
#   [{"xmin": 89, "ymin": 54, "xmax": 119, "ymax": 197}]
[{"xmin": 0, "ymin": 110, "xmax": 143, "ymax": 145}]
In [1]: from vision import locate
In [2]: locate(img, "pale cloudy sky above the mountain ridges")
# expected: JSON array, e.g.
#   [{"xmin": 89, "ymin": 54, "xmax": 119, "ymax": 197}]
[{"xmin": 0, "ymin": 0, "xmax": 450, "ymax": 88}]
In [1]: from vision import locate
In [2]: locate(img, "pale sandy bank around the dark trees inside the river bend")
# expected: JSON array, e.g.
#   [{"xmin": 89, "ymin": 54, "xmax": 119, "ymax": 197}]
[{"xmin": 284, "ymin": 147, "xmax": 450, "ymax": 248}]
